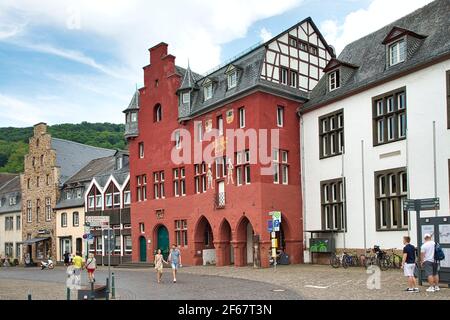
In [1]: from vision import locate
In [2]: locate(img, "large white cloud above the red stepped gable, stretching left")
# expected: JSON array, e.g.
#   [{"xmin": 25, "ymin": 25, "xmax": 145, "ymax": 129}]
[{"xmin": 0, "ymin": 0, "xmax": 302, "ymax": 75}]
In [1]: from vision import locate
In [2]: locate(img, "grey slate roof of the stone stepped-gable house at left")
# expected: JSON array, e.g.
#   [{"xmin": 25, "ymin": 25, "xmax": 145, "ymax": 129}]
[{"xmin": 52, "ymin": 138, "xmax": 116, "ymax": 185}]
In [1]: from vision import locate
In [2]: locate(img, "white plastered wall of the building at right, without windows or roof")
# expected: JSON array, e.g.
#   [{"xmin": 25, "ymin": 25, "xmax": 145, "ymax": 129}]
[{"xmin": 302, "ymin": 60, "xmax": 450, "ymax": 259}]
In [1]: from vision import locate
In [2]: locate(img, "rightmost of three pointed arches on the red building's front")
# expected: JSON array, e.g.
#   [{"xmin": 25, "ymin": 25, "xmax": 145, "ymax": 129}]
[{"xmin": 234, "ymin": 217, "xmax": 255, "ymax": 267}]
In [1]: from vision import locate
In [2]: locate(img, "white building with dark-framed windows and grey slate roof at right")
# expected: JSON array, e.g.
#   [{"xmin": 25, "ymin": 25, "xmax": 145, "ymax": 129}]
[{"xmin": 300, "ymin": 0, "xmax": 450, "ymax": 261}]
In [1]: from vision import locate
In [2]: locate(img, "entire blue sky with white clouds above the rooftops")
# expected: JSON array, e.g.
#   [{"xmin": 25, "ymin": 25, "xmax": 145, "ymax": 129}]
[{"xmin": 0, "ymin": 0, "xmax": 431, "ymax": 127}]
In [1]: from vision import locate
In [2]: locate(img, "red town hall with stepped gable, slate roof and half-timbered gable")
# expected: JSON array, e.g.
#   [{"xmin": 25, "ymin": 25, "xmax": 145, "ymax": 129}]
[{"xmin": 124, "ymin": 18, "xmax": 334, "ymax": 267}]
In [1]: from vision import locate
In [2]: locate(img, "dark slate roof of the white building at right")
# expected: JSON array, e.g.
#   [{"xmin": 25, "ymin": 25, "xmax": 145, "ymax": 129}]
[{"xmin": 301, "ymin": 0, "xmax": 450, "ymax": 111}]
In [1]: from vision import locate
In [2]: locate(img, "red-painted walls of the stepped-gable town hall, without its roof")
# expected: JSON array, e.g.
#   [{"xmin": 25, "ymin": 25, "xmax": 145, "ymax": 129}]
[{"xmin": 129, "ymin": 43, "xmax": 303, "ymax": 267}]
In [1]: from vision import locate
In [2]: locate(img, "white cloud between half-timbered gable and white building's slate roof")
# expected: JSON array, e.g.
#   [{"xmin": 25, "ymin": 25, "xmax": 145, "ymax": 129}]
[{"xmin": 320, "ymin": 0, "xmax": 432, "ymax": 53}]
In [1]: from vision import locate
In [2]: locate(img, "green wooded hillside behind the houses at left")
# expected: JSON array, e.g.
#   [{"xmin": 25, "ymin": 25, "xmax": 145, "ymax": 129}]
[{"xmin": 0, "ymin": 122, "xmax": 126, "ymax": 173}]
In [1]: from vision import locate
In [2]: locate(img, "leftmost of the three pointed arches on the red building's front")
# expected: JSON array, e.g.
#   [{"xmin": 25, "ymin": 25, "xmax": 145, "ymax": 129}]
[{"xmin": 194, "ymin": 216, "xmax": 216, "ymax": 265}]
